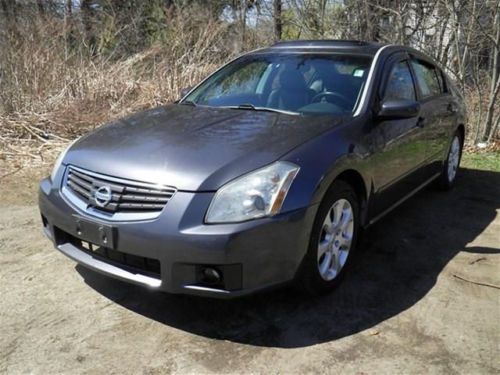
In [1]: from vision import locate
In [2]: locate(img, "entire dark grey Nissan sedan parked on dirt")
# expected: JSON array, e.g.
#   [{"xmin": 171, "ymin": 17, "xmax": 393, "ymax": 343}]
[{"xmin": 39, "ymin": 40, "xmax": 465, "ymax": 298}]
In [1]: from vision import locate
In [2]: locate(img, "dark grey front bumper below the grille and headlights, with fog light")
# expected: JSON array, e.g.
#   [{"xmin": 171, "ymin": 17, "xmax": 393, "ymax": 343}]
[{"xmin": 39, "ymin": 179, "xmax": 317, "ymax": 298}]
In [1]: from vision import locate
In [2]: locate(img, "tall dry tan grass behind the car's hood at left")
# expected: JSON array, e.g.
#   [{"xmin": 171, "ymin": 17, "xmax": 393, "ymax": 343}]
[{"xmin": 0, "ymin": 8, "xmax": 246, "ymax": 176}]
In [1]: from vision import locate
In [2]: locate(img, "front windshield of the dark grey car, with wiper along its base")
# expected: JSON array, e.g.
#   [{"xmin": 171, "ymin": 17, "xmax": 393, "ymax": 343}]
[{"xmin": 181, "ymin": 53, "xmax": 371, "ymax": 114}]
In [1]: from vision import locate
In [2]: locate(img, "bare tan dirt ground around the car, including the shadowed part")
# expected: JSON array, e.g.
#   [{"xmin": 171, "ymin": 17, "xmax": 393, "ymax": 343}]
[{"xmin": 0, "ymin": 169, "xmax": 500, "ymax": 374}]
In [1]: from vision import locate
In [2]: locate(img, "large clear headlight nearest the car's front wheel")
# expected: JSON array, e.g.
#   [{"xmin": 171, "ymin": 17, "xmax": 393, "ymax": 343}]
[{"xmin": 205, "ymin": 162, "xmax": 299, "ymax": 223}]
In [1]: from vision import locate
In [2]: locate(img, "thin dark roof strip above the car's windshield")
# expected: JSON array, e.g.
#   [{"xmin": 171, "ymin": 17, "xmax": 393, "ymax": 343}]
[{"xmin": 256, "ymin": 39, "xmax": 386, "ymax": 56}]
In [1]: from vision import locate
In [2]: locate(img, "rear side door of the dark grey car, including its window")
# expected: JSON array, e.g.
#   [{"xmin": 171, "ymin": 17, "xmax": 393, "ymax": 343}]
[{"xmin": 411, "ymin": 56, "xmax": 457, "ymax": 178}]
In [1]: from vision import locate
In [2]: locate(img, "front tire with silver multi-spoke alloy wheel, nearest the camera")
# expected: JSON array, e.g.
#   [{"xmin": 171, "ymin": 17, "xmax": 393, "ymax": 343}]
[{"xmin": 296, "ymin": 180, "xmax": 359, "ymax": 295}]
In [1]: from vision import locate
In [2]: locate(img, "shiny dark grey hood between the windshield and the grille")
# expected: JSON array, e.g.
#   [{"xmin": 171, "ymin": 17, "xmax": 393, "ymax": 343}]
[{"xmin": 64, "ymin": 105, "xmax": 341, "ymax": 191}]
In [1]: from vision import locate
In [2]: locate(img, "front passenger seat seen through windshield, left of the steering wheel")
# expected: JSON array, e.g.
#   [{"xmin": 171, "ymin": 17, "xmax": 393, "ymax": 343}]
[{"xmin": 267, "ymin": 67, "xmax": 312, "ymax": 111}]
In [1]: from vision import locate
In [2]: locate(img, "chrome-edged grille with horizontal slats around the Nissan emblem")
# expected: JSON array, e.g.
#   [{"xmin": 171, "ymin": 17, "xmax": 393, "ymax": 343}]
[{"xmin": 63, "ymin": 166, "xmax": 176, "ymax": 219}]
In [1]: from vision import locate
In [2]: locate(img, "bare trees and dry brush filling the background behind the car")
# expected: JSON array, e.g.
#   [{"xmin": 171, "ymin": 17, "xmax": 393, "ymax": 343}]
[{"xmin": 0, "ymin": 0, "xmax": 500, "ymax": 156}]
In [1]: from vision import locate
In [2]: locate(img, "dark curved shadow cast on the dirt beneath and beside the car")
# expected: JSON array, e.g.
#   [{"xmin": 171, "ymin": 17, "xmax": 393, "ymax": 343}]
[{"xmin": 77, "ymin": 169, "xmax": 500, "ymax": 348}]
